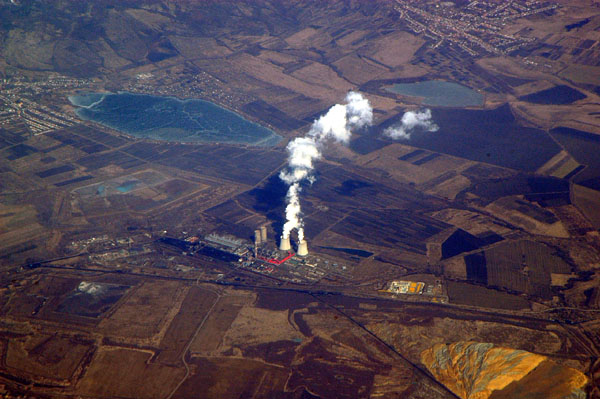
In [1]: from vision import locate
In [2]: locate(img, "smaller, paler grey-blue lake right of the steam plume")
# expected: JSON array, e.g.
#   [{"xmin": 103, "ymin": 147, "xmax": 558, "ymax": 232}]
[{"xmin": 385, "ymin": 80, "xmax": 484, "ymax": 107}]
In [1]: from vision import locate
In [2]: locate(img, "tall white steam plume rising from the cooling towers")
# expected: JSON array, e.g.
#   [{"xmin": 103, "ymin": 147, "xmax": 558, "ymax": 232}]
[{"xmin": 279, "ymin": 91, "xmax": 373, "ymax": 240}]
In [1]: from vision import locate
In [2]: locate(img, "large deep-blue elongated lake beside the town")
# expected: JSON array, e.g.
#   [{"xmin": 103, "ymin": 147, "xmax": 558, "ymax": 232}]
[{"xmin": 69, "ymin": 92, "xmax": 281, "ymax": 146}]
